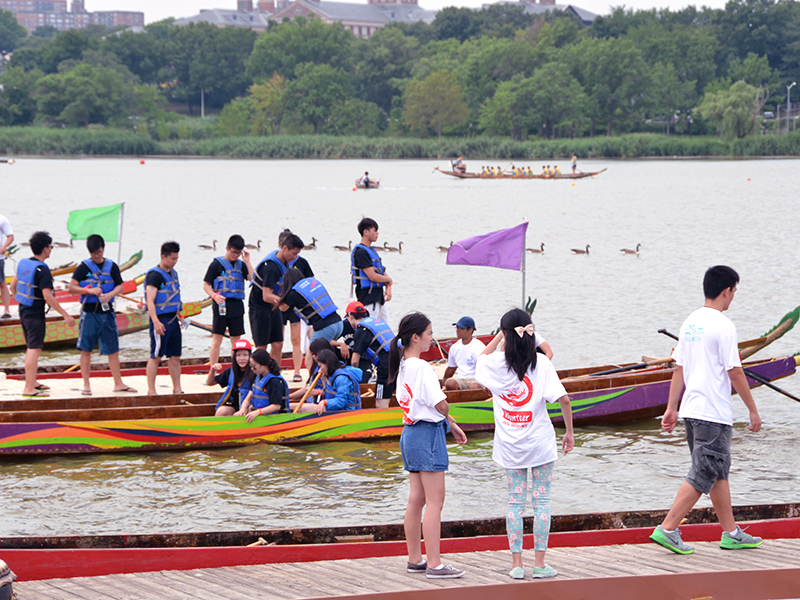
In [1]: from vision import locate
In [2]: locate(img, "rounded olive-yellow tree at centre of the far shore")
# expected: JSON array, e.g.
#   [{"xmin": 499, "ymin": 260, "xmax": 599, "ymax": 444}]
[{"xmin": 403, "ymin": 71, "xmax": 470, "ymax": 139}]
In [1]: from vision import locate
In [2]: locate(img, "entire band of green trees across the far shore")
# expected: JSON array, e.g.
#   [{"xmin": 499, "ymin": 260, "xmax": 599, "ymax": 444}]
[{"xmin": 0, "ymin": 0, "xmax": 800, "ymax": 140}]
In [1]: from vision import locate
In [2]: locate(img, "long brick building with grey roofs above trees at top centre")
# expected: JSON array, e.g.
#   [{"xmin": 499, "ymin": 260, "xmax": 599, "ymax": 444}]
[{"xmin": 175, "ymin": 0, "xmax": 436, "ymax": 39}]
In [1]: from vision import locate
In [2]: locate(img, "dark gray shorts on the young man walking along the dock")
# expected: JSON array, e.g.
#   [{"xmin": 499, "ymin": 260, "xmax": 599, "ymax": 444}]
[{"xmin": 683, "ymin": 419, "xmax": 733, "ymax": 494}]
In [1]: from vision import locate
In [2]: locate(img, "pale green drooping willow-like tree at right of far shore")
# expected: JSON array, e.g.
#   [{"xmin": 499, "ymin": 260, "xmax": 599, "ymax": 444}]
[{"xmin": 697, "ymin": 81, "xmax": 764, "ymax": 140}]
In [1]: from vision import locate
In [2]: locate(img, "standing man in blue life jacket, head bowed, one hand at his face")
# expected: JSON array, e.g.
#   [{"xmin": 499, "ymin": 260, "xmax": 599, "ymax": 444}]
[{"xmin": 203, "ymin": 234, "xmax": 253, "ymax": 365}]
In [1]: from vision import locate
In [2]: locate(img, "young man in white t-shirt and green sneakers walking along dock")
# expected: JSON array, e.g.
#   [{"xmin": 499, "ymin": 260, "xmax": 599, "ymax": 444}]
[{"xmin": 650, "ymin": 265, "xmax": 762, "ymax": 554}]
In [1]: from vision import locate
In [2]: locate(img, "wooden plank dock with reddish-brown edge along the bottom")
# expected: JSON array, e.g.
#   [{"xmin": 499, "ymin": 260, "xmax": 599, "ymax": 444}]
[{"xmin": 10, "ymin": 539, "xmax": 800, "ymax": 600}]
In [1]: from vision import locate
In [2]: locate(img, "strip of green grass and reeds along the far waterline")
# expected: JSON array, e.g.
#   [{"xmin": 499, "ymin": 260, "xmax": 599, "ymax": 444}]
[{"xmin": 0, "ymin": 127, "xmax": 800, "ymax": 160}]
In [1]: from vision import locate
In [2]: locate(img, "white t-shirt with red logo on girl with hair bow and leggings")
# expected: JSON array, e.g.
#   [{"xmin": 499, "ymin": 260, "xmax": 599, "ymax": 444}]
[{"xmin": 475, "ymin": 352, "xmax": 567, "ymax": 469}]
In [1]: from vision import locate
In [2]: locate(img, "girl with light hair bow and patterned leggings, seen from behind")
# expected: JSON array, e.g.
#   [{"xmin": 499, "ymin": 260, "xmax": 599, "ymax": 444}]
[{"xmin": 475, "ymin": 308, "xmax": 575, "ymax": 579}]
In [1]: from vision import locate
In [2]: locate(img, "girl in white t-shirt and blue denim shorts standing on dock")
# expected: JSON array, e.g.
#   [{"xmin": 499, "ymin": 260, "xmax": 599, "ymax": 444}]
[{"xmin": 389, "ymin": 312, "xmax": 467, "ymax": 579}]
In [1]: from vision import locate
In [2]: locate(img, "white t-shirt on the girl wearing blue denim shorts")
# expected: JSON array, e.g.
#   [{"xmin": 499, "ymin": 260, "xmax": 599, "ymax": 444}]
[{"xmin": 396, "ymin": 357, "xmax": 447, "ymax": 425}]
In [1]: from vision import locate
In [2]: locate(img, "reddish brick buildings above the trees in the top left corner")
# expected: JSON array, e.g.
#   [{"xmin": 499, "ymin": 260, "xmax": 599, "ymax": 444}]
[{"xmin": 0, "ymin": 0, "xmax": 144, "ymax": 33}]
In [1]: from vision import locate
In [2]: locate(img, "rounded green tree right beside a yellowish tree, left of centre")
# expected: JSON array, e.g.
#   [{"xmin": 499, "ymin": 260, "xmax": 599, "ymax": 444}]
[{"xmin": 283, "ymin": 63, "xmax": 353, "ymax": 134}]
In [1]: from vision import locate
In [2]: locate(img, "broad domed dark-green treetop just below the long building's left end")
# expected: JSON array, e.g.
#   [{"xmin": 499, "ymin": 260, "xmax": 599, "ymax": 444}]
[{"xmin": 247, "ymin": 17, "xmax": 355, "ymax": 82}]
